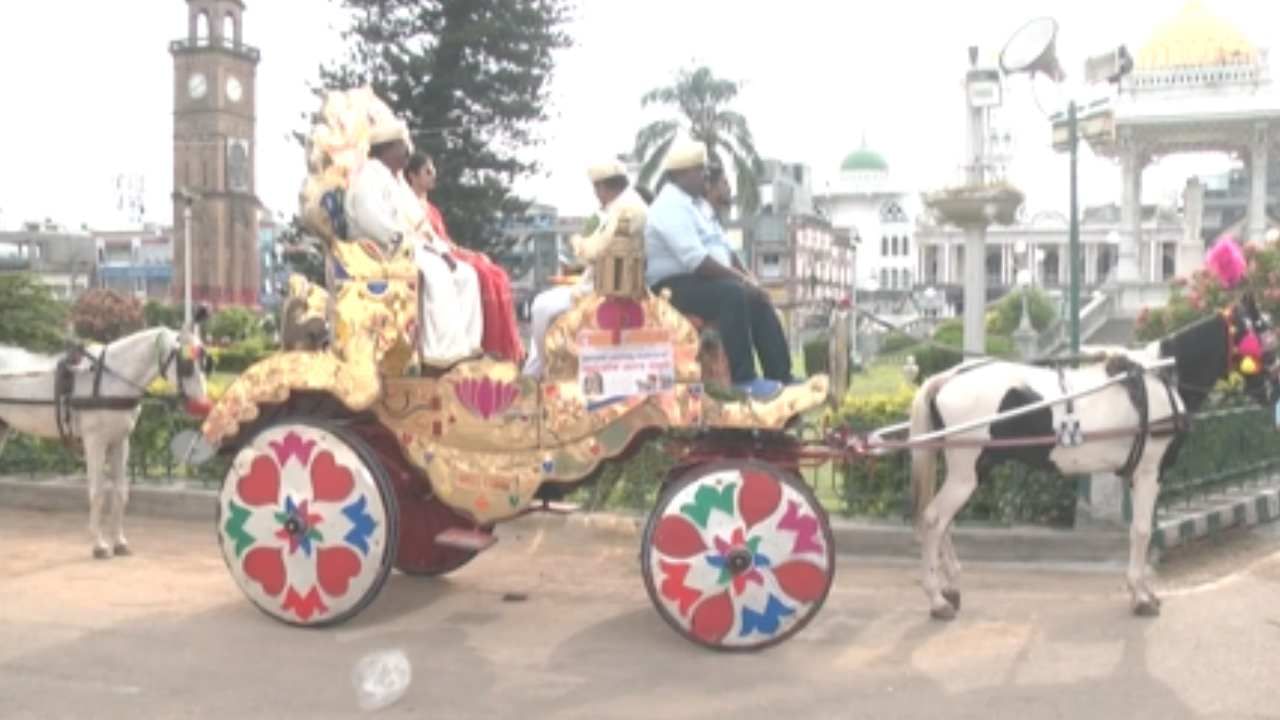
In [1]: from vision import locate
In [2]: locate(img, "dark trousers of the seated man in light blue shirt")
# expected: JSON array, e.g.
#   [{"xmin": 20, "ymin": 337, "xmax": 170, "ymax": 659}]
[{"xmin": 654, "ymin": 275, "xmax": 791, "ymax": 383}]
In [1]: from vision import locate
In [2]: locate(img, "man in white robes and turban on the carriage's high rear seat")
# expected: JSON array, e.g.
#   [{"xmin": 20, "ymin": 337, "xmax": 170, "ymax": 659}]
[{"xmin": 346, "ymin": 120, "xmax": 484, "ymax": 366}]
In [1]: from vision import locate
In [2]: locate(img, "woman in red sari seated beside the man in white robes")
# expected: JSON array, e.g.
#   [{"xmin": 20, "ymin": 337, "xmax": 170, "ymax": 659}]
[{"xmin": 404, "ymin": 152, "xmax": 525, "ymax": 364}]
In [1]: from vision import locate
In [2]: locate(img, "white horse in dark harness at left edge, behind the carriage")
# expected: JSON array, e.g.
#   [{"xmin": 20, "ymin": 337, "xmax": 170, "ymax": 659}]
[{"xmin": 0, "ymin": 328, "xmax": 209, "ymax": 559}]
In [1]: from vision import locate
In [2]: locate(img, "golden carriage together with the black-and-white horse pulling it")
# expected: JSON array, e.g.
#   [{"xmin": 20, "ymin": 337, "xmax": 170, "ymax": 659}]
[{"xmin": 204, "ymin": 85, "xmax": 1276, "ymax": 650}]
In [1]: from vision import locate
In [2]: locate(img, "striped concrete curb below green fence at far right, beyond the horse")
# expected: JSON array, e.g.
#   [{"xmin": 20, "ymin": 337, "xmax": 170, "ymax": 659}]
[{"xmin": 1152, "ymin": 479, "xmax": 1280, "ymax": 555}]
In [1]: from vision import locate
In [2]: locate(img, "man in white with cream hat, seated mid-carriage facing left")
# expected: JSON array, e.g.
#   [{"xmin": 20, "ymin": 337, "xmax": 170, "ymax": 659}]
[{"xmin": 524, "ymin": 160, "xmax": 646, "ymax": 378}]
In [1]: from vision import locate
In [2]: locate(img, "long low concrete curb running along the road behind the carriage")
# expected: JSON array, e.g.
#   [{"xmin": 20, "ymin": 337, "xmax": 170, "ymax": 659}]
[{"xmin": 0, "ymin": 478, "xmax": 1129, "ymax": 564}]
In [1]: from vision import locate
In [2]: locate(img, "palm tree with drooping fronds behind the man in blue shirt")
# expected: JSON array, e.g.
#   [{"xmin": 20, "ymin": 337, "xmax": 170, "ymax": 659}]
[{"xmin": 632, "ymin": 65, "xmax": 760, "ymax": 213}]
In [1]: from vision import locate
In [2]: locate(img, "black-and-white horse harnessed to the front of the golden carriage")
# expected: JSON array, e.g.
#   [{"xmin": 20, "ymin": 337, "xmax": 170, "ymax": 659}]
[{"xmin": 911, "ymin": 296, "xmax": 1276, "ymax": 620}]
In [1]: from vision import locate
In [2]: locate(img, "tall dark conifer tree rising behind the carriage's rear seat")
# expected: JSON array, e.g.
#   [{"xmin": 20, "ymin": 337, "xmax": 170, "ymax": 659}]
[{"xmin": 320, "ymin": 0, "xmax": 571, "ymax": 250}]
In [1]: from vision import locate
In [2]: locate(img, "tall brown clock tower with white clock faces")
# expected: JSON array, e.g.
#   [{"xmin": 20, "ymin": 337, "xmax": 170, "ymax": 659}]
[{"xmin": 169, "ymin": 0, "xmax": 261, "ymax": 307}]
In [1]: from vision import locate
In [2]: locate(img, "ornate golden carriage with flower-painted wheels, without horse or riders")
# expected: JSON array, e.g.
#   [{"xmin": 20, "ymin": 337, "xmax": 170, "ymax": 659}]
[{"xmin": 204, "ymin": 91, "xmax": 847, "ymax": 648}]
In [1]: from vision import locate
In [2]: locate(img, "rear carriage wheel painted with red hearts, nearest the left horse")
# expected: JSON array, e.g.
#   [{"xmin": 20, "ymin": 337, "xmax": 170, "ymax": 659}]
[{"xmin": 218, "ymin": 420, "xmax": 397, "ymax": 626}]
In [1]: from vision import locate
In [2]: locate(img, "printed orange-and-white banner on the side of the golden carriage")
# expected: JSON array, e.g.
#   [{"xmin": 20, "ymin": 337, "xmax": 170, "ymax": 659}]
[{"xmin": 577, "ymin": 331, "xmax": 676, "ymax": 401}]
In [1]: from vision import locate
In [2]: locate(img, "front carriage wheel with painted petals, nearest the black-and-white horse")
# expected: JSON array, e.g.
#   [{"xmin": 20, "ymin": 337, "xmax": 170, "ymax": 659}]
[{"xmin": 641, "ymin": 460, "xmax": 836, "ymax": 651}]
